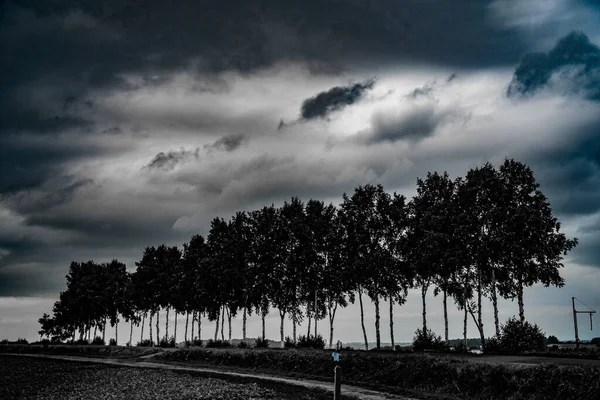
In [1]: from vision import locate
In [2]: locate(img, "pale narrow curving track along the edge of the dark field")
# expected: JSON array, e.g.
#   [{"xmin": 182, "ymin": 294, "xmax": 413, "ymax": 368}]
[{"xmin": 0, "ymin": 354, "xmax": 414, "ymax": 400}]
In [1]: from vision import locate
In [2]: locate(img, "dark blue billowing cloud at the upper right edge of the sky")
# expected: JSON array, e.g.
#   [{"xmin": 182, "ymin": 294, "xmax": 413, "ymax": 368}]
[{"xmin": 507, "ymin": 32, "xmax": 600, "ymax": 101}]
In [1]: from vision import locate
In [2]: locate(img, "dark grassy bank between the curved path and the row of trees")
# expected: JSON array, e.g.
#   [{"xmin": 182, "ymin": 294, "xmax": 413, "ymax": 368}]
[{"xmin": 157, "ymin": 349, "xmax": 600, "ymax": 400}]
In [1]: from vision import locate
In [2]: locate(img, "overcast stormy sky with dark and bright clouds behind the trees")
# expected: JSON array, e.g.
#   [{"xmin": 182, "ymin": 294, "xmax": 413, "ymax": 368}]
[{"xmin": 0, "ymin": 0, "xmax": 600, "ymax": 342}]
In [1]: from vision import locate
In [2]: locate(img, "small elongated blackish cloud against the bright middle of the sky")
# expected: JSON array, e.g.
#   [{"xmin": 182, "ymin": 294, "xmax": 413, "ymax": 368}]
[{"xmin": 300, "ymin": 78, "xmax": 375, "ymax": 120}]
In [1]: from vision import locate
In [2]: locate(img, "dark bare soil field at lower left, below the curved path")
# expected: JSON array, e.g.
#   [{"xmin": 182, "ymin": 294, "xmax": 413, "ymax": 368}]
[{"xmin": 0, "ymin": 355, "xmax": 331, "ymax": 400}]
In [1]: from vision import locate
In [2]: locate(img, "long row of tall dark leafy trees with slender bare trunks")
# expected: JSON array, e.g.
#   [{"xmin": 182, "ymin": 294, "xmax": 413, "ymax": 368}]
[{"xmin": 40, "ymin": 159, "xmax": 577, "ymax": 347}]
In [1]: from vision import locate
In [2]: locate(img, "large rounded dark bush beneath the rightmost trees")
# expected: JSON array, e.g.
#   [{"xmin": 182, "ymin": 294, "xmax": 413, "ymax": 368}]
[{"xmin": 500, "ymin": 317, "xmax": 546, "ymax": 354}]
